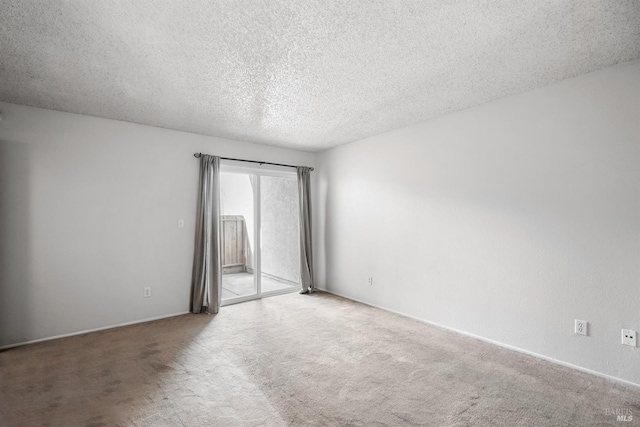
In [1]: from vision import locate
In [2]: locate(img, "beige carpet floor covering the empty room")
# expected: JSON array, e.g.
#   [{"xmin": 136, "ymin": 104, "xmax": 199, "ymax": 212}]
[{"xmin": 0, "ymin": 293, "xmax": 640, "ymax": 427}]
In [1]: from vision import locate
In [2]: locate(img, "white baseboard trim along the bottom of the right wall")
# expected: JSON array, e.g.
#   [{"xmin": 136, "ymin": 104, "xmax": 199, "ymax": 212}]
[{"xmin": 317, "ymin": 288, "xmax": 640, "ymax": 389}]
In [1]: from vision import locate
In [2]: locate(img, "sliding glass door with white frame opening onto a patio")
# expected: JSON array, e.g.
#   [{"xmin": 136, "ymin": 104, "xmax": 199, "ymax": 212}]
[{"xmin": 220, "ymin": 162, "xmax": 300, "ymax": 305}]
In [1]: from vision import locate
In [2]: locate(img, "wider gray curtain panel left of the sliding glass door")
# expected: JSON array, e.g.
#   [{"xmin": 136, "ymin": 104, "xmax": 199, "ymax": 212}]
[{"xmin": 191, "ymin": 154, "xmax": 222, "ymax": 314}]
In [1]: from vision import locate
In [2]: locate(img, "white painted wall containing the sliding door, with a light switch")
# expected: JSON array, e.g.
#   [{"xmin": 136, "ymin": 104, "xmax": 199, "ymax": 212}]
[{"xmin": 0, "ymin": 103, "xmax": 314, "ymax": 346}]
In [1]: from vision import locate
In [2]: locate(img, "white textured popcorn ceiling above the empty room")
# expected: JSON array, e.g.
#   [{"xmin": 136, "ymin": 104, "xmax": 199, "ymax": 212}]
[{"xmin": 0, "ymin": 0, "xmax": 640, "ymax": 151}]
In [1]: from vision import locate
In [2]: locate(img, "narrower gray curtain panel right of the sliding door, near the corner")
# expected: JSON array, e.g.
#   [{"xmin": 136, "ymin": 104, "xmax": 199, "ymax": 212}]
[{"xmin": 297, "ymin": 167, "xmax": 315, "ymax": 294}]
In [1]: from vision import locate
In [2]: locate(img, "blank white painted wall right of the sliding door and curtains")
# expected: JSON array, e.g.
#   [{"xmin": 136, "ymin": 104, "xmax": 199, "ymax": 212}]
[{"xmin": 314, "ymin": 61, "xmax": 640, "ymax": 384}]
